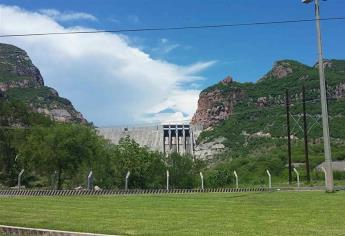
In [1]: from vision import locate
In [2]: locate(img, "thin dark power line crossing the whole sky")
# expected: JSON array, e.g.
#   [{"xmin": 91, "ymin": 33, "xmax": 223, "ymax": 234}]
[{"xmin": 0, "ymin": 16, "xmax": 345, "ymax": 38}]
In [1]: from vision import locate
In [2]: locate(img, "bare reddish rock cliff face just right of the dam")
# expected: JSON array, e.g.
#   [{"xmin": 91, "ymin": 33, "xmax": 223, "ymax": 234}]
[{"xmin": 191, "ymin": 76, "xmax": 245, "ymax": 128}]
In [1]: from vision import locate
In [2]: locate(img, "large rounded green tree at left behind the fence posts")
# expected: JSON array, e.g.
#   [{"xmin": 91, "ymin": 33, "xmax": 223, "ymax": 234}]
[{"xmin": 21, "ymin": 124, "xmax": 103, "ymax": 189}]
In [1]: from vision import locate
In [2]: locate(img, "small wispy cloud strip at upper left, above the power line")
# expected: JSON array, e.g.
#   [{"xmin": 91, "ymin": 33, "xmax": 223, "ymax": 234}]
[{"xmin": 39, "ymin": 9, "xmax": 97, "ymax": 22}]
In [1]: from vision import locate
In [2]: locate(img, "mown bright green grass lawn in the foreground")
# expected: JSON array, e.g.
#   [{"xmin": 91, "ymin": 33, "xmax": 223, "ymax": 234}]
[{"xmin": 0, "ymin": 192, "xmax": 345, "ymax": 236}]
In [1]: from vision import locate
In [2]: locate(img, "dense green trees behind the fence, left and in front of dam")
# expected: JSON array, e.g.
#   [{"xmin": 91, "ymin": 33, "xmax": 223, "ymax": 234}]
[{"xmin": 0, "ymin": 99, "xmax": 204, "ymax": 189}]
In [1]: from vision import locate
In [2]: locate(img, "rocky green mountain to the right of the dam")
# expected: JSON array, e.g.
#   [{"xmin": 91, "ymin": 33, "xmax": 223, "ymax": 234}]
[{"xmin": 192, "ymin": 60, "xmax": 345, "ymax": 159}]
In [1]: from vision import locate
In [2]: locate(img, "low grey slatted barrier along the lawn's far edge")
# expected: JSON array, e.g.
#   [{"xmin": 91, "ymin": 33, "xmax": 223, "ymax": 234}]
[{"xmin": 0, "ymin": 187, "xmax": 269, "ymax": 197}]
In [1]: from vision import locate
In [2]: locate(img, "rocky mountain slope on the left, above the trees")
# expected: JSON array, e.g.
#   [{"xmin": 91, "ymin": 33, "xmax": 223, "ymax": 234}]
[{"xmin": 0, "ymin": 44, "xmax": 86, "ymax": 123}]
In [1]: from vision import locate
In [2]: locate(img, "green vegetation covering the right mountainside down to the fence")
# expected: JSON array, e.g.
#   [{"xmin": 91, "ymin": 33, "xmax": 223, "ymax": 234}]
[{"xmin": 198, "ymin": 60, "xmax": 345, "ymax": 185}]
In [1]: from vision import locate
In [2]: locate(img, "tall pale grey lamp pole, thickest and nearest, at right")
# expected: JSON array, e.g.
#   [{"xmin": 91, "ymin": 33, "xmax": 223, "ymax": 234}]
[{"xmin": 315, "ymin": 0, "xmax": 334, "ymax": 192}]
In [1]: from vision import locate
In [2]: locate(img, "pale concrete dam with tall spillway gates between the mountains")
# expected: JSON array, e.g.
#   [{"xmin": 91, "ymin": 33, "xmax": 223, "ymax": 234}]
[{"xmin": 97, "ymin": 124, "xmax": 202, "ymax": 155}]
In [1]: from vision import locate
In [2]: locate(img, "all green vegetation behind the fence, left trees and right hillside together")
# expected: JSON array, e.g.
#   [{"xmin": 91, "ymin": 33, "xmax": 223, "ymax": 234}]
[{"xmin": 0, "ymin": 60, "xmax": 345, "ymax": 189}]
